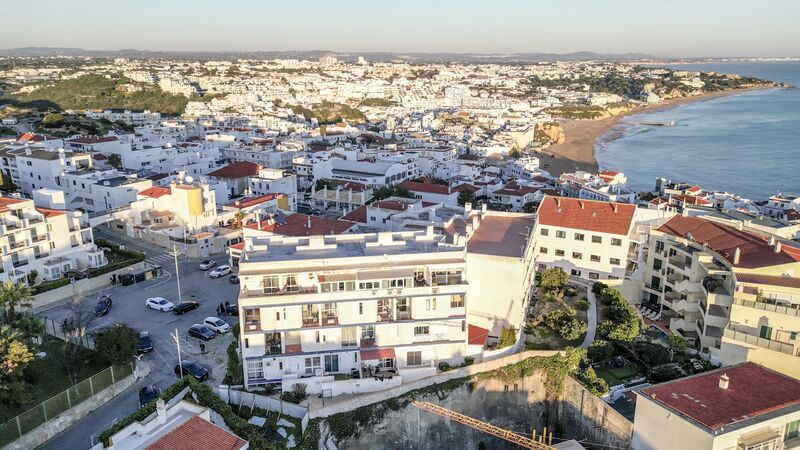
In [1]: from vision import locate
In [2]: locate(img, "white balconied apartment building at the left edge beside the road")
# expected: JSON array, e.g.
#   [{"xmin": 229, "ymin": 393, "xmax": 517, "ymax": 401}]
[{"xmin": 0, "ymin": 192, "xmax": 108, "ymax": 282}]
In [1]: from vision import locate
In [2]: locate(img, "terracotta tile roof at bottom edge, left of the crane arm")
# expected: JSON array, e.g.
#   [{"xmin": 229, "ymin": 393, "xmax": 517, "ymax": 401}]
[{"xmin": 146, "ymin": 416, "xmax": 247, "ymax": 450}]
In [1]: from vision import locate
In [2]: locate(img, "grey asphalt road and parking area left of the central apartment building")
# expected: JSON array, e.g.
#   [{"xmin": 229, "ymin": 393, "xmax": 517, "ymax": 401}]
[{"xmin": 38, "ymin": 229, "xmax": 239, "ymax": 450}]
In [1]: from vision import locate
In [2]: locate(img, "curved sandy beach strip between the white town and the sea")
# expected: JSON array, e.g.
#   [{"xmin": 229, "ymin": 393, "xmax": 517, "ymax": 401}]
[{"xmin": 537, "ymin": 86, "xmax": 776, "ymax": 177}]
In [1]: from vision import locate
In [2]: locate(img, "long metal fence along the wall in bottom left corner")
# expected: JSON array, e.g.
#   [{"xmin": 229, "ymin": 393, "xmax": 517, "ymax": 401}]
[{"xmin": 0, "ymin": 364, "xmax": 133, "ymax": 446}]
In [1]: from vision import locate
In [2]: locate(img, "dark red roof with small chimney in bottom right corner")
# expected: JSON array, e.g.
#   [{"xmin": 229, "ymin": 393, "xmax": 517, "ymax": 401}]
[{"xmin": 640, "ymin": 363, "xmax": 800, "ymax": 430}]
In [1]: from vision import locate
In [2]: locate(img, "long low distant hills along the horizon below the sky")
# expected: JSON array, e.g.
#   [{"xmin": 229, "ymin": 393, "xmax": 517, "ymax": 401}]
[{"xmin": 0, "ymin": 47, "xmax": 657, "ymax": 63}]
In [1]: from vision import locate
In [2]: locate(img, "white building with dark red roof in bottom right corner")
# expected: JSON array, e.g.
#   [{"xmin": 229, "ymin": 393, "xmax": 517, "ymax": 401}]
[{"xmin": 631, "ymin": 363, "xmax": 800, "ymax": 450}]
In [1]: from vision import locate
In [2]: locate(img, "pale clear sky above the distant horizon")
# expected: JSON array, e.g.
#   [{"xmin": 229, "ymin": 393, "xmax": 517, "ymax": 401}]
[{"xmin": 0, "ymin": 0, "xmax": 800, "ymax": 57}]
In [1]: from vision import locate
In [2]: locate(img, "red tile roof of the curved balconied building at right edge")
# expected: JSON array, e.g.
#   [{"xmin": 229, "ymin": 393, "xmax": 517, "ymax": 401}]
[{"xmin": 657, "ymin": 216, "xmax": 800, "ymax": 268}]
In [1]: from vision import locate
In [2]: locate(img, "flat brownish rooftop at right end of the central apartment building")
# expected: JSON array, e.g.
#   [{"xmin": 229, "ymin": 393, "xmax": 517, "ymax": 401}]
[{"xmin": 467, "ymin": 213, "xmax": 535, "ymax": 258}]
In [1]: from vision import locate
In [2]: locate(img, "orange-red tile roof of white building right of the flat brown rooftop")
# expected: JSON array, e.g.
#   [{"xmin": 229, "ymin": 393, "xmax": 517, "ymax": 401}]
[{"xmin": 538, "ymin": 195, "xmax": 636, "ymax": 235}]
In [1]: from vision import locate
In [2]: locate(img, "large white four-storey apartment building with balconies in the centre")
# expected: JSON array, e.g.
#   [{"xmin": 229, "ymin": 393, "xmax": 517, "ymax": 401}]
[{"xmin": 234, "ymin": 209, "xmax": 533, "ymax": 395}]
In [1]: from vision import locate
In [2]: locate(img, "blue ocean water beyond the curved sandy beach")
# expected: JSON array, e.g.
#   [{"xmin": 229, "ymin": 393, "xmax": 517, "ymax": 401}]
[{"xmin": 595, "ymin": 61, "xmax": 800, "ymax": 200}]
